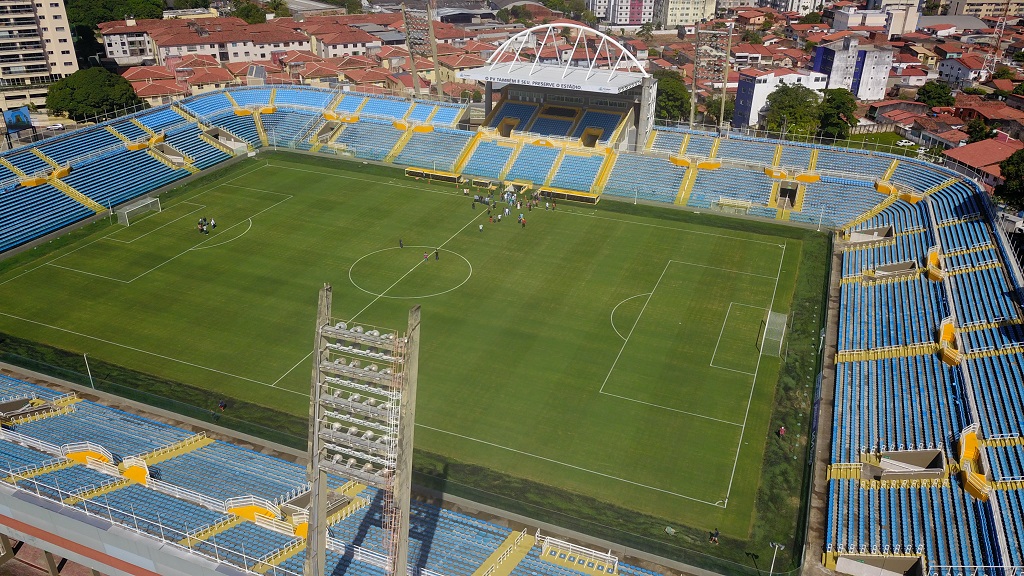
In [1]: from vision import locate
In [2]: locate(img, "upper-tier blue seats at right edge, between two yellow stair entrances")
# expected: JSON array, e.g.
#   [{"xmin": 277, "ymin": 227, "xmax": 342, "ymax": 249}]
[{"xmin": 967, "ymin": 355, "xmax": 1024, "ymax": 437}]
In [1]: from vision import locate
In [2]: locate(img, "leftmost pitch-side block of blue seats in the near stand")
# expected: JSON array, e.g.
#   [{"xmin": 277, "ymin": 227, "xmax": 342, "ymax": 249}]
[{"xmin": 14, "ymin": 402, "xmax": 189, "ymax": 458}]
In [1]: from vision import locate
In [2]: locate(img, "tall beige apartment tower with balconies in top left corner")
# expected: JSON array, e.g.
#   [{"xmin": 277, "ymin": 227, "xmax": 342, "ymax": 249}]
[{"xmin": 0, "ymin": 0, "xmax": 78, "ymax": 110}]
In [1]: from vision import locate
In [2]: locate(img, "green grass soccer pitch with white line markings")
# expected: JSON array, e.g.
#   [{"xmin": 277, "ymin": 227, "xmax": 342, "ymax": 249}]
[{"xmin": 0, "ymin": 155, "xmax": 802, "ymax": 539}]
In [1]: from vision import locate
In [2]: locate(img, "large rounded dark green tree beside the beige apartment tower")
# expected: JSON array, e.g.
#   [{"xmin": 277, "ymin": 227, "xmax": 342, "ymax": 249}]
[{"xmin": 46, "ymin": 67, "xmax": 142, "ymax": 120}]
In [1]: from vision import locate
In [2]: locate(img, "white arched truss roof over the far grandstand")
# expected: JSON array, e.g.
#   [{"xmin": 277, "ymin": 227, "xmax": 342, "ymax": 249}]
[{"xmin": 459, "ymin": 24, "xmax": 648, "ymax": 94}]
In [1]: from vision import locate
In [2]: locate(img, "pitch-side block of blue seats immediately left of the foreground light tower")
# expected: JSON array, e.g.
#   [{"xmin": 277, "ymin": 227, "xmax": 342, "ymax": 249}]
[{"xmin": 150, "ymin": 442, "xmax": 303, "ymax": 500}]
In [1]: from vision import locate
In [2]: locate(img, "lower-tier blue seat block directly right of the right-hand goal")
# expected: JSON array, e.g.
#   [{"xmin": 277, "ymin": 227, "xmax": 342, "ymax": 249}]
[{"xmin": 839, "ymin": 275, "xmax": 949, "ymax": 351}]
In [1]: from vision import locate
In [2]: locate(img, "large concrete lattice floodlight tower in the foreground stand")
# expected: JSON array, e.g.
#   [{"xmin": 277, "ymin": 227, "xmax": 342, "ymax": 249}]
[{"xmin": 305, "ymin": 285, "xmax": 420, "ymax": 576}]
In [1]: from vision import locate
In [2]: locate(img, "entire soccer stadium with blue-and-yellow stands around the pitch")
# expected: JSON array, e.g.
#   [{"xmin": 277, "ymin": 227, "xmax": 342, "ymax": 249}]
[{"xmin": 0, "ymin": 24, "xmax": 1024, "ymax": 576}]
